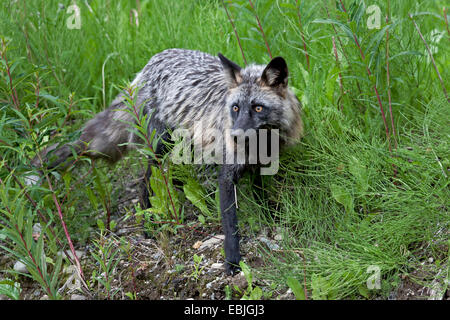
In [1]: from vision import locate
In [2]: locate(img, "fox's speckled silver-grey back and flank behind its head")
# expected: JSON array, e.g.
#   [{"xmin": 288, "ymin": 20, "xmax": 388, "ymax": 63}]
[{"xmin": 133, "ymin": 49, "xmax": 227, "ymax": 134}]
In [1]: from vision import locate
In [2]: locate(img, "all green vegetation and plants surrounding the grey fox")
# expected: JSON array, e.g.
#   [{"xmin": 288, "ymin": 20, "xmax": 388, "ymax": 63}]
[{"xmin": 0, "ymin": 0, "xmax": 450, "ymax": 299}]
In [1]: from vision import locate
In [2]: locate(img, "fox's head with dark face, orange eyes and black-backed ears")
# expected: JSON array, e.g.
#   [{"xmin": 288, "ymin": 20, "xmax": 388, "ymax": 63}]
[{"xmin": 219, "ymin": 53, "xmax": 302, "ymax": 145}]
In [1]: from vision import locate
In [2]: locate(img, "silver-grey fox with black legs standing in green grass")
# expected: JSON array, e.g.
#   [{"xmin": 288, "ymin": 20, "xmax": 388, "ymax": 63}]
[{"xmin": 32, "ymin": 49, "xmax": 303, "ymax": 275}]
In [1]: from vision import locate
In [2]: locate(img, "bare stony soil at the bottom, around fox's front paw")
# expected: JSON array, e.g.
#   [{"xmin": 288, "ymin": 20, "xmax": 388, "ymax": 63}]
[{"xmin": 0, "ymin": 212, "xmax": 284, "ymax": 300}]
